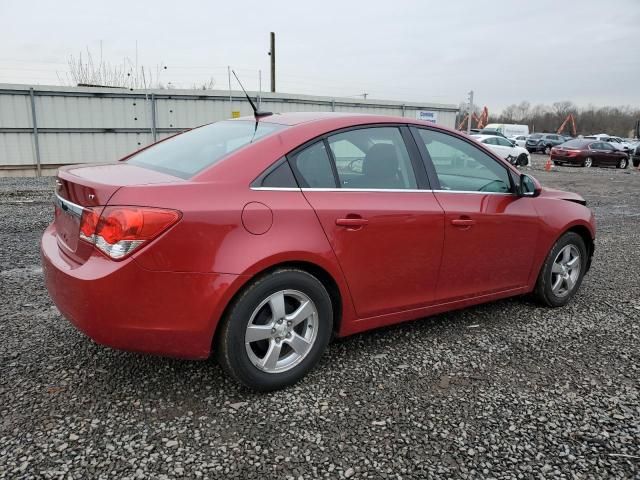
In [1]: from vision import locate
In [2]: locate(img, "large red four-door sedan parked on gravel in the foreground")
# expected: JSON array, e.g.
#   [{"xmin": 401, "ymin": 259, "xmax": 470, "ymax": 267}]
[{"xmin": 41, "ymin": 113, "xmax": 595, "ymax": 390}]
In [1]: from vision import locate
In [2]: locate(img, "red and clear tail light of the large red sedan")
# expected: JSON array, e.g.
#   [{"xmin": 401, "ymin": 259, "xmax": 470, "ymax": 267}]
[{"xmin": 80, "ymin": 206, "xmax": 180, "ymax": 260}]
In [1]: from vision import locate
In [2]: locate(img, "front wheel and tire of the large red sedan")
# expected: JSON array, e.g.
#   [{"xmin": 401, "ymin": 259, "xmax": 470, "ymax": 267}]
[{"xmin": 535, "ymin": 232, "xmax": 588, "ymax": 307}]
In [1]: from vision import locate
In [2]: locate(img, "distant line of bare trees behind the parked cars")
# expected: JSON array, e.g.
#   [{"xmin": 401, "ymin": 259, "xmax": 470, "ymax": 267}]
[{"xmin": 458, "ymin": 101, "xmax": 640, "ymax": 137}]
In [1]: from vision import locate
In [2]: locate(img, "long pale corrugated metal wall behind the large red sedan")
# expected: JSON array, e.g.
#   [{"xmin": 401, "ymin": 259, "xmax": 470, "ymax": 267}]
[{"xmin": 0, "ymin": 84, "xmax": 457, "ymax": 176}]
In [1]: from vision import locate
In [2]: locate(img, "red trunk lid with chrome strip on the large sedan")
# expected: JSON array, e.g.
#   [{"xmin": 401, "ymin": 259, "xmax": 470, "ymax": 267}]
[{"xmin": 54, "ymin": 162, "xmax": 184, "ymax": 263}]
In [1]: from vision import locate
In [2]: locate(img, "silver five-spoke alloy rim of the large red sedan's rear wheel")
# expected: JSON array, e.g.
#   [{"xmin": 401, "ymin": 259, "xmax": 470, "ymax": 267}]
[{"xmin": 245, "ymin": 290, "xmax": 318, "ymax": 373}]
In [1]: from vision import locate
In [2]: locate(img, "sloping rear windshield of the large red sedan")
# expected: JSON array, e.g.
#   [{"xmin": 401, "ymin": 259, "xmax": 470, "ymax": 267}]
[{"xmin": 127, "ymin": 120, "xmax": 285, "ymax": 178}]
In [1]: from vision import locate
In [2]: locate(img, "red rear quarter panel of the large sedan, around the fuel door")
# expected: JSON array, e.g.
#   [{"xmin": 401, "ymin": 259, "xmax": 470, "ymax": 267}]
[{"xmin": 110, "ymin": 182, "xmax": 355, "ymax": 336}]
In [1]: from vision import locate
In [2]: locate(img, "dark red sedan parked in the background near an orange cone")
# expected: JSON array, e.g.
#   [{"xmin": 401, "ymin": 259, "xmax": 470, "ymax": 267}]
[{"xmin": 551, "ymin": 139, "xmax": 629, "ymax": 168}]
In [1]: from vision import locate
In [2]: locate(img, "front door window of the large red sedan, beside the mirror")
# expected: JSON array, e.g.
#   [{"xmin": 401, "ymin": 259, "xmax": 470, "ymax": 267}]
[{"xmin": 418, "ymin": 129, "xmax": 511, "ymax": 193}]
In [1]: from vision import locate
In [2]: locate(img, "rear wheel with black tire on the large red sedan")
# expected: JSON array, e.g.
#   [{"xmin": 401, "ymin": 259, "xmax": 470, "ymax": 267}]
[{"xmin": 216, "ymin": 269, "xmax": 333, "ymax": 391}]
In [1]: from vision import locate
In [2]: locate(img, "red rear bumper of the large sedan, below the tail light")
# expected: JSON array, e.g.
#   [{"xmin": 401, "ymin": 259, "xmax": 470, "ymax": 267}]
[{"xmin": 41, "ymin": 225, "xmax": 238, "ymax": 359}]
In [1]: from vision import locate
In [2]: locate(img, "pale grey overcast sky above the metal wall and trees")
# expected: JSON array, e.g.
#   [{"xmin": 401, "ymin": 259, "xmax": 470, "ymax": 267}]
[{"xmin": 0, "ymin": 0, "xmax": 640, "ymax": 111}]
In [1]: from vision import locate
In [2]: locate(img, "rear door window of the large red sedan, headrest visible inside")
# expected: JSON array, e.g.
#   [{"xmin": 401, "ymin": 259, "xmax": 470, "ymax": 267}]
[{"xmin": 327, "ymin": 127, "xmax": 418, "ymax": 190}]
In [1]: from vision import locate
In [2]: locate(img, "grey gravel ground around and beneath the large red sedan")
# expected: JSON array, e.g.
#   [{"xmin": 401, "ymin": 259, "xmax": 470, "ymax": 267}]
[{"xmin": 0, "ymin": 156, "xmax": 640, "ymax": 479}]
